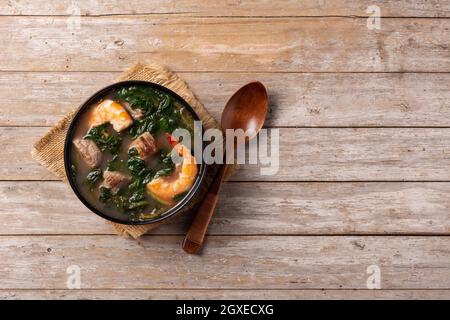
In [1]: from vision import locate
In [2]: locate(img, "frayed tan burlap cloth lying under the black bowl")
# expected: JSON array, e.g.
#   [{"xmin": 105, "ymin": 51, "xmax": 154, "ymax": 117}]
[{"xmin": 31, "ymin": 64, "xmax": 224, "ymax": 239}]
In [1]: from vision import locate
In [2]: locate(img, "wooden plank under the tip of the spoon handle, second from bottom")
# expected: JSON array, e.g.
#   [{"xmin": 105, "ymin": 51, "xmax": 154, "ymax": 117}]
[{"xmin": 0, "ymin": 236, "xmax": 450, "ymax": 290}]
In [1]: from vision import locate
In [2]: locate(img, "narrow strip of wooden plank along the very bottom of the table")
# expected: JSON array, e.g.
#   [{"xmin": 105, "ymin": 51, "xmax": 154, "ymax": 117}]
[{"xmin": 0, "ymin": 289, "xmax": 450, "ymax": 300}]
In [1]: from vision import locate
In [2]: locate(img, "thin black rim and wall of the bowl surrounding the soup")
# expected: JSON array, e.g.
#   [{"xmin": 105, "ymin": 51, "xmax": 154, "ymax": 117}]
[{"xmin": 64, "ymin": 80, "xmax": 206, "ymax": 225}]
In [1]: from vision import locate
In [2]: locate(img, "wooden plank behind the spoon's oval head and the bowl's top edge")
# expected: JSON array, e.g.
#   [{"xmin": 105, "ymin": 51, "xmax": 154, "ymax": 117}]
[{"xmin": 0, "ymin": 72, "xmax": 450, "ymax": 127}]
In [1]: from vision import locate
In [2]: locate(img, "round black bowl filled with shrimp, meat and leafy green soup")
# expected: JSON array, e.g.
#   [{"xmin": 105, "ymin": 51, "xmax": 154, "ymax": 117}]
[{"xmin": 64, "ymin": 81, "xmax": 206, "ymax": 224}]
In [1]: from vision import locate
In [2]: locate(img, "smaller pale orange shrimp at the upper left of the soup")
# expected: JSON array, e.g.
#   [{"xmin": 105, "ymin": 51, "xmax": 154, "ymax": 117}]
[{"xmin": 89, "ymin": 100, "xmax": 133, "ymax": 132}]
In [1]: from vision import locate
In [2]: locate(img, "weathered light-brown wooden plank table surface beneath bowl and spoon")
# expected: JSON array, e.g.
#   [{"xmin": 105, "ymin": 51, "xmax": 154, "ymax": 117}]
[{"xmin": 0, "ymin": 0, "xmax": 450, "ymax": 299}]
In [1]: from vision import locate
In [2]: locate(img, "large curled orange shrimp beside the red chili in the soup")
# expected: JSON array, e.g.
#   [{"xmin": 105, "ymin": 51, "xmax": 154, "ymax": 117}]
[{"xmin": 147, "ymin": 138, "xmax": 198, "ymax": 205}]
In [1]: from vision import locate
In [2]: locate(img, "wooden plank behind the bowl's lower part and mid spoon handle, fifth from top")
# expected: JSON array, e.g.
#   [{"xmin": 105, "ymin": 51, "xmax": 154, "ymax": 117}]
[{"xmin": 0, "ymin": 181, "xmax": 450, "ymax": 235}]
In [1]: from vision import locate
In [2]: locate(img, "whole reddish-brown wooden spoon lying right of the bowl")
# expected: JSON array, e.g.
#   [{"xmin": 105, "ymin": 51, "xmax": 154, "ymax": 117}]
[{"xmin": 182, "ymin": 82, "xmax": 269, "ymax": 254}]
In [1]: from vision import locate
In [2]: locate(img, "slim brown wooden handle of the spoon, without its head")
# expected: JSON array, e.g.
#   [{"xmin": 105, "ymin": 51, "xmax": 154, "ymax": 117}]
[{"xmin": 182, "ymin": 164, "xmax": 228, "ymax": 254}]
